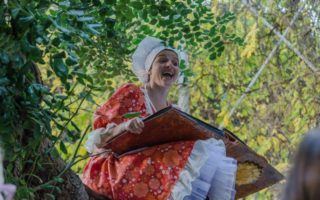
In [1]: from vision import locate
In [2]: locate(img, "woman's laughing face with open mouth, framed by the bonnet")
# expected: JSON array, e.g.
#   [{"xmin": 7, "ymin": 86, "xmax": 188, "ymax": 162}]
[{"xmin": 149, "ymin": 50, "xmax": 179, "ymax": 87}]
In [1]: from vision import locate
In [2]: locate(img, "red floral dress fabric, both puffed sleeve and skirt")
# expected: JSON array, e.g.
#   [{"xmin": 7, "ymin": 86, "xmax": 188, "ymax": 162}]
[{"xmin": 83, "ymin": 84, "xmax": 195, "ymax": 200}]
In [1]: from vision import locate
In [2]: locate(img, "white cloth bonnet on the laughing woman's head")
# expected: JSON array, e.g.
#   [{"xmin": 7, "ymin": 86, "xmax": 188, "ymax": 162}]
[{"xmin": 132, "ymin": 36, "xmax": 179, "ymax": 83}]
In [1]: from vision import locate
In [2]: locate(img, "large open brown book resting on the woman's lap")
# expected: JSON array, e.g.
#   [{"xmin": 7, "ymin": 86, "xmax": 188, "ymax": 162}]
[{"xmin": 105, "ymin": 107, "xmax": 283, "ymax": 198}]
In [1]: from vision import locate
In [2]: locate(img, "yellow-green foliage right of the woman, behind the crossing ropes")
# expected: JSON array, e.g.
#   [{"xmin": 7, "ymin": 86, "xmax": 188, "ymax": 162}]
[{"xmin": 189, "ymin": 0, "xmax": 320, "ymax": 200}]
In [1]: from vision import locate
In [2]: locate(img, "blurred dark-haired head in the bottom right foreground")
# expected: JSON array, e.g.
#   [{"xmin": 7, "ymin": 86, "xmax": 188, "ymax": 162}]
[{"xmin": 284, "ymin": 128, "xmax": 320, "ymax": 200}]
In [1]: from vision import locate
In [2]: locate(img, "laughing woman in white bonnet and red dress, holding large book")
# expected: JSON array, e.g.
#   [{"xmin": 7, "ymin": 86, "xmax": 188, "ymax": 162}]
[{"xmin": 83, "ymin": 37, "xmax": 236, "ymax": 200}]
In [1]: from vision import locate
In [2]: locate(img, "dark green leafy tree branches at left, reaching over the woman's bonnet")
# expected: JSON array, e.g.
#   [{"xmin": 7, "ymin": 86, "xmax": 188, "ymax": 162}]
[{"xmin": 0, "ymin": 0, "xmax": 243, "ymax": 199}]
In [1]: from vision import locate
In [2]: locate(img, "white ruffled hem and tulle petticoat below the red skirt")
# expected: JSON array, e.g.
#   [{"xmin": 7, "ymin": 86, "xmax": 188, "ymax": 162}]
[{"xmin": 169, "ymin": 138, "xmax": 237, "ymax": 200}]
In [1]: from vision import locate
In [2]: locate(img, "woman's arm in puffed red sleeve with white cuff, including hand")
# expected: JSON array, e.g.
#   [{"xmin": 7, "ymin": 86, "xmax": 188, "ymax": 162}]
[{"xmin": 86, "ymin": 84, "xmax": 144, "ymax": 152}]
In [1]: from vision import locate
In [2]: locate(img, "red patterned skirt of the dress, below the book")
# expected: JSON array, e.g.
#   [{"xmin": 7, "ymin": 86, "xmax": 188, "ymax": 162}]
[{"xmin": 83, "ymin": 141, "xmax": 195, "ymax": 200}]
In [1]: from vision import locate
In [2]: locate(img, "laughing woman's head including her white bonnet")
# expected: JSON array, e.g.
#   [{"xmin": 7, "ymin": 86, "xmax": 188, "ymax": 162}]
[{"xmin": 132, "ymin": 37, "xmax": 179, "ymax": 87}]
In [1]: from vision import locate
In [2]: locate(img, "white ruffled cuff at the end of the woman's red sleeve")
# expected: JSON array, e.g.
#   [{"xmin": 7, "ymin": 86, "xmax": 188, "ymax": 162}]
[{"xmin": 84, "ymin": 123, "xmax": 116, "ymax": 153}]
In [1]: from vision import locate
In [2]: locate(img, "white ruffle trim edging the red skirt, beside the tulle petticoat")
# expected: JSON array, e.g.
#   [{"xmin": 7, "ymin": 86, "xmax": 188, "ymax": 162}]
[{"xmin": 169, "ymin": 138, "xmax": 221, "ymax": 200}]
